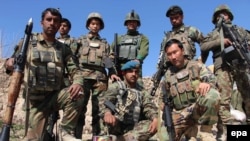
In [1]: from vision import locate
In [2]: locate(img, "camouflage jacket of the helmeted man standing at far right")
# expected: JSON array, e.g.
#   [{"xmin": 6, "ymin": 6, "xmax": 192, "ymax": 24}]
[{"xmin": 201, "ymin": 22, "xmax": 250, "ymax": 71}]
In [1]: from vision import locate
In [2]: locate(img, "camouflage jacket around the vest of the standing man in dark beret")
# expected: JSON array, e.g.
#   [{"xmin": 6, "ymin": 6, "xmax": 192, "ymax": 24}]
[{"xmin": 160, "ymin": 24, "xmax": 204, "ymax": 59}]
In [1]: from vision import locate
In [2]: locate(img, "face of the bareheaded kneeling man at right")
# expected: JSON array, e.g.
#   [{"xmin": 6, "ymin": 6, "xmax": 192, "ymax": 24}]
[{"xmin": 165, "ymin": 43, "xmax": 185, "ymax": 68}]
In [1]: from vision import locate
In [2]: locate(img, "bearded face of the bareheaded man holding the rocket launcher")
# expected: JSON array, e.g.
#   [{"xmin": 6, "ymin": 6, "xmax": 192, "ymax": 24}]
[{"xmin": 41, "ymin": 12, "xmax": 61, "ymax": 36}]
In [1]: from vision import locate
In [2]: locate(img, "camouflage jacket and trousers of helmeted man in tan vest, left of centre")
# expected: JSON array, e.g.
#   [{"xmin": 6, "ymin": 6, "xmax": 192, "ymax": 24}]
[{"xmin": 71, "ymin": 34, "xmax": 110, "ymax": 138}]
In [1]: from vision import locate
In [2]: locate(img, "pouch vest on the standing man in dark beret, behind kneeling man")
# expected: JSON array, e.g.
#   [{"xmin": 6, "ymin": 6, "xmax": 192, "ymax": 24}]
[{"xmin": 163, "ymin": 27, "xmax": 196, "ymax": 60}]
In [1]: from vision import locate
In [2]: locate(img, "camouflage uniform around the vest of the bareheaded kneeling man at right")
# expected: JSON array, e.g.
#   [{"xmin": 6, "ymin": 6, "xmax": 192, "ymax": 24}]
[{"xmin": 161, "ymin": 61, "xmax": 220, "ymax": 139}]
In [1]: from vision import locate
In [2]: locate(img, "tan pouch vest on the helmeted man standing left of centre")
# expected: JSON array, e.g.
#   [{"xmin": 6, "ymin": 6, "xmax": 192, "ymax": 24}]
[{"xmin": 78, "ymin": 36, "xmax": 107, "ymax": 68}]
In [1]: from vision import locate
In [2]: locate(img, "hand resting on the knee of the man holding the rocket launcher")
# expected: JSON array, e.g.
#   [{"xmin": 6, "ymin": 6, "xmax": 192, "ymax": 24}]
[{"xmin": 68, "ymin": 84, "xmax": 83, "ymax": 100}]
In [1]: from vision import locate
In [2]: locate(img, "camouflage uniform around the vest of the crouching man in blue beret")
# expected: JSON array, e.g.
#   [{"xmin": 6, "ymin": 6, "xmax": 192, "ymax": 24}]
[{"xmin": 99, "ymin": 82, "xmax": 158, "ymax": 140}]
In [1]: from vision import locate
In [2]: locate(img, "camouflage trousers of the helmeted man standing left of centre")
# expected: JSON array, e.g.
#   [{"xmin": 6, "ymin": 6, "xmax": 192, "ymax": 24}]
[{"xmin": 76, "ymin": 79, "xmax": 108, "ymax": 138}]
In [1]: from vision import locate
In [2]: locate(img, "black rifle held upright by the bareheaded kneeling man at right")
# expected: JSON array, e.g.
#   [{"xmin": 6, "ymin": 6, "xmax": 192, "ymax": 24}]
[{"xmin": 161, "ymin": 83, "xmax": 175, "ymax": 141}]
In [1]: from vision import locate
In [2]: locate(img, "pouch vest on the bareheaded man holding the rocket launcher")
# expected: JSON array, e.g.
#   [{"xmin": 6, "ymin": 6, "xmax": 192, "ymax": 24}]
[{"xmin": 27, "ymin": 34, "xmax": 64, "ymax": 92}]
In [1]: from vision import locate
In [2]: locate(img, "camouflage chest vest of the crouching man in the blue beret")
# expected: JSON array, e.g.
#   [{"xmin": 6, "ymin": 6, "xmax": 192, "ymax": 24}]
[{"xmin": 116, "ymin": 81, "xmax": 142, "ymax": 125}]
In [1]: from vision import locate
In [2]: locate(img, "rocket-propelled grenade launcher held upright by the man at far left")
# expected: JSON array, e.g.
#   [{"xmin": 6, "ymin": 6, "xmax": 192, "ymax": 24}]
[{"xmin": 0, "ymin": 18, "xmax": 33, "ymax": 141}]
